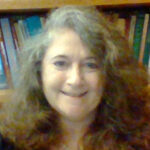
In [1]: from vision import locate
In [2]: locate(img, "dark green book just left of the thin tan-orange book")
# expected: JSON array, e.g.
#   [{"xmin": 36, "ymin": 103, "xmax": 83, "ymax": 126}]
[{"xmin": 133, "ymin": 12, "xmax": 145, "ymax": 60}]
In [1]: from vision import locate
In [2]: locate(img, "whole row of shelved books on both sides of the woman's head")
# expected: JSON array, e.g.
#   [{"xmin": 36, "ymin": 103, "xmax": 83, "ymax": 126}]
[{"xmin": 0, "ymin": 12, "xmax": 150, "ymax": 89}]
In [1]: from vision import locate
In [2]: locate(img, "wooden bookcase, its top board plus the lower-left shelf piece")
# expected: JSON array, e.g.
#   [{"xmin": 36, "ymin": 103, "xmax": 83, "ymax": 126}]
[{"xmin": 0, "ymin": 0, "xmax": 150, "ymax": 103}]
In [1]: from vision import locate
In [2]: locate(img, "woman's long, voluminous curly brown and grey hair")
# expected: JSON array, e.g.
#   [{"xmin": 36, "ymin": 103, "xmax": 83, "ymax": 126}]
[{"xmin": 0, "ymin": 6, "xmax": 150, "ymax": 150}]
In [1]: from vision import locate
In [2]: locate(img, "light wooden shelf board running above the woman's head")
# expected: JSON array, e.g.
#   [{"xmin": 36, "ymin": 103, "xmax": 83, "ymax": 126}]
[{"xmin": 0, "ymin": 0, "xmax": 150, "ymax": 12}]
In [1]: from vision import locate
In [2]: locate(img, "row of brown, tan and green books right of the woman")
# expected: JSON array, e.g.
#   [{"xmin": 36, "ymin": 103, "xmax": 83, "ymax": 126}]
[{"xmin": 106, "ymin": 12, "xmax": 150, "ymax": 72}]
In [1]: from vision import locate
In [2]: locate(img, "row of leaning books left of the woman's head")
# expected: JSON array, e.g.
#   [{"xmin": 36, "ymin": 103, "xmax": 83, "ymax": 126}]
[{"xmin": 0, "ymin": 15, "xmax": 45, "ymax": 89}]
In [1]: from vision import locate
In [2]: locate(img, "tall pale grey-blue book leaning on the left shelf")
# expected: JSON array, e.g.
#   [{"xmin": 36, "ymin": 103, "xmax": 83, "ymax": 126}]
[{"xmin": 0, "ymin": 18, "xmax": 19, "ymax": 87}]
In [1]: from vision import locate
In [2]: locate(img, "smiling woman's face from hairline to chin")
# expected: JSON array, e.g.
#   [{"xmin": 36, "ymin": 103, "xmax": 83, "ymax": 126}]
[{"xmin": 42, "ymin": 29, "xmax": 104, "ymax": 121}]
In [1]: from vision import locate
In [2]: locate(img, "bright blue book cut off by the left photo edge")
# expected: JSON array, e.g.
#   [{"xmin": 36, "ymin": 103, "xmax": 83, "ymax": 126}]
[{"xmin": 0, "ymin": 54, "xmax": 8, "ymax": 89}]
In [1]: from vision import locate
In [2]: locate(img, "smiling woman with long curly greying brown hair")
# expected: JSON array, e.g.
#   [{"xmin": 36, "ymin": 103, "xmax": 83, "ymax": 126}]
[{"xmin": 0, "ymin": 6, "xmax": 150, "ymax": 150}]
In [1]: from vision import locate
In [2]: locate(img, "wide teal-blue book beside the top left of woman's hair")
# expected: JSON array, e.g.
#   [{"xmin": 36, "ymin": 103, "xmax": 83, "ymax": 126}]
[{"xmin": 25, "ymin": 16, "xmax": 42, "ymax": 37}]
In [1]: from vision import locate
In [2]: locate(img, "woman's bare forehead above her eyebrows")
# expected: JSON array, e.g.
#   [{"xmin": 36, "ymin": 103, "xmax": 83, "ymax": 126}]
[{"xmin": 46, "ymin": 29, "xmax": 92, "ymax": 57}]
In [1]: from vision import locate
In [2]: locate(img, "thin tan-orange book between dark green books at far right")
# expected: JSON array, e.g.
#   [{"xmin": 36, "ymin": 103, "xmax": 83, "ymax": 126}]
[{"xmin": 138, "ymin": 14, "xmax": 149, "ymax": 65}]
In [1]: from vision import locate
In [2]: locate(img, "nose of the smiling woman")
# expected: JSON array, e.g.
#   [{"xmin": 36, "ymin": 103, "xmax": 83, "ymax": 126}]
[{"xmin": 67, "ymin": 64, "xmax": 84, "ymax": 88}]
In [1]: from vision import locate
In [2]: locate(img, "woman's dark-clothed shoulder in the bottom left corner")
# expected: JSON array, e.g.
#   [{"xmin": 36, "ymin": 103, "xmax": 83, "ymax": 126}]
[{"xmin": 0, "ymin": 134, "xmax": 15, "ymax": 150}]
